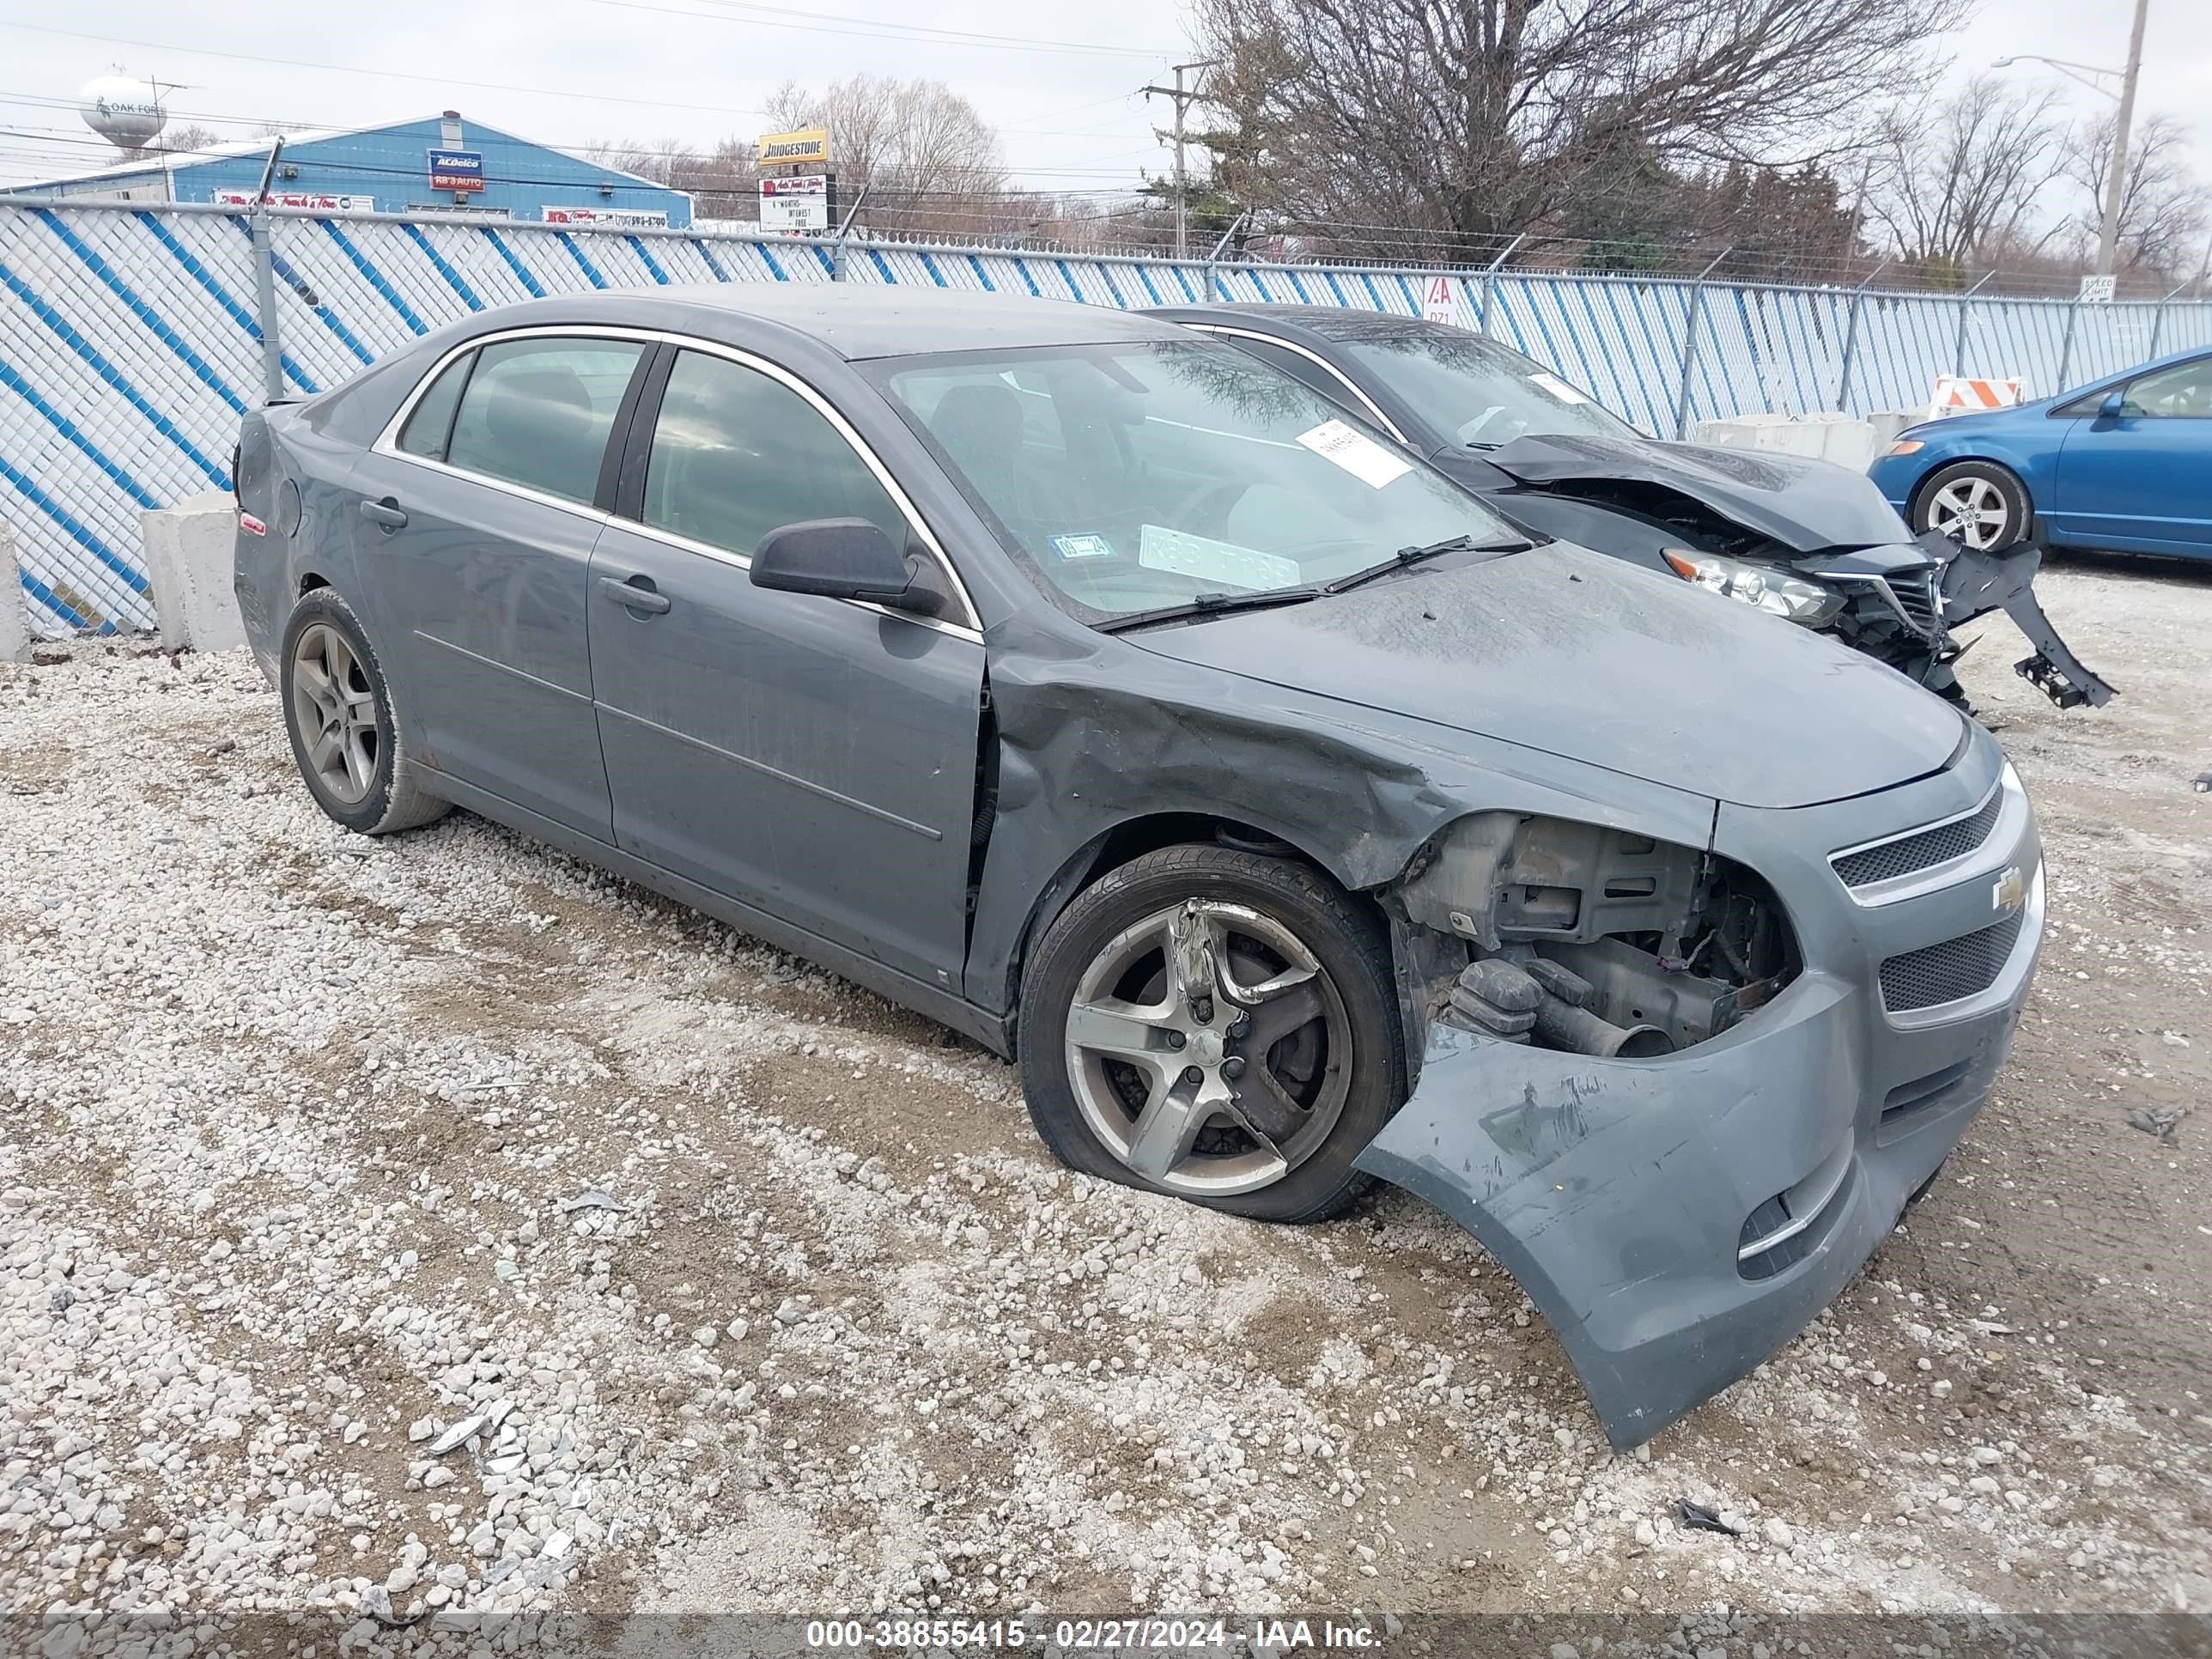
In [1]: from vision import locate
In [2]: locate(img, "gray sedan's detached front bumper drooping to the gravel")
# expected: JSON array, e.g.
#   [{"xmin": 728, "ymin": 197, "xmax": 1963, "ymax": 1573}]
[{"xmin": 1358, "ymin": 738, "xmax": 2042, "ymax": 1449}]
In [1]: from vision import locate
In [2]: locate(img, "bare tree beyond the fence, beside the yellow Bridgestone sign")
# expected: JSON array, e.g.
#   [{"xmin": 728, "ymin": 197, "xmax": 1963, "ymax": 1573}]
[{"xmin": 768, "ymin": 76, "xmax": 1004, "ymax": 234}]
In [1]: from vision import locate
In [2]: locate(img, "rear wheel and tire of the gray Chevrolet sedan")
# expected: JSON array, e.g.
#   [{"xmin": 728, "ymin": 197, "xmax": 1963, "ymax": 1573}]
[{"xmin": 276, "ymin": 588, "xmax": 453, "ymax": 836}]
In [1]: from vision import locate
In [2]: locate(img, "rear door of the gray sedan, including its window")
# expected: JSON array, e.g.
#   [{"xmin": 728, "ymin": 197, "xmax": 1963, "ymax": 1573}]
[{"xmin": 354, "ymin": 330, "xmax": 653, "ymax": 841}]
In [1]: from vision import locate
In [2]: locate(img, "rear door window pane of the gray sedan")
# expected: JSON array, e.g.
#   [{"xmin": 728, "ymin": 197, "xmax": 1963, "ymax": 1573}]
[{"xmin": 445, "ymin": 337, "xmax": 646, "ymax": 502}]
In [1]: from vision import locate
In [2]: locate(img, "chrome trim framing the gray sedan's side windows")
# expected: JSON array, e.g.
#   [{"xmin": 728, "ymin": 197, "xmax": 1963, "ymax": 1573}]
[{"xmin": 369, "ymin": 323, "xmax": 986, "ymax": 644}]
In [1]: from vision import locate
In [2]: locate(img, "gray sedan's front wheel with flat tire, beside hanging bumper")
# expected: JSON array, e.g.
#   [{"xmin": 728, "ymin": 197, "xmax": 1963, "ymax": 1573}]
[{"xmin": 1018, "ymin": 845, "xmax": 1405, "ymax": 1221}]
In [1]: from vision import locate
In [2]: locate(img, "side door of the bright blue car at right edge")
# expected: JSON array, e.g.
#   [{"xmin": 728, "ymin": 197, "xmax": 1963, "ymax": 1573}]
[{"xmin": 2048, "ymin": 356, "xmax": 2212, "ymax": 557}]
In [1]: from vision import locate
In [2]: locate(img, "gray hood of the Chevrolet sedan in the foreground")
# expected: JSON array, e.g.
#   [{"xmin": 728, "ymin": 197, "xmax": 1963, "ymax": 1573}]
[{"xmin": 1124, "ymin": 542, "xmax": 1964, "ymax": 807}]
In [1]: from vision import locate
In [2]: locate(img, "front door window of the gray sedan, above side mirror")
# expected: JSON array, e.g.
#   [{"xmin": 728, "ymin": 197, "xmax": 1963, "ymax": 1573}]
[{"xmin": 644, "ymin": 352, "xmax": 907, "ymax": 557}]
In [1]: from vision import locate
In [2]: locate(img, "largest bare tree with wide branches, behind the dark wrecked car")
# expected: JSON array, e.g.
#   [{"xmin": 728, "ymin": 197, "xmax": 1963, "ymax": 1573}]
[{"xmin": 1197, "ymin": 0, "xmax": 1971, "ymax": 252}]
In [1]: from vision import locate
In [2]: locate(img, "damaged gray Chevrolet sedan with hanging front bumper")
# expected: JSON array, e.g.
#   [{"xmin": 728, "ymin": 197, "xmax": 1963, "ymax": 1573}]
[{"xmin": 237, "ymin": 285, "xmax": 2044, "ymax": 1447}]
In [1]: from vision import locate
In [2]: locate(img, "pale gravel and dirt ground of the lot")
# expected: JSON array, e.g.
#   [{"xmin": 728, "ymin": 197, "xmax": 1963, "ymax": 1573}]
[{"xmin": 0, "ymin": 564, "xmax": 2212, "ymax": 1637}]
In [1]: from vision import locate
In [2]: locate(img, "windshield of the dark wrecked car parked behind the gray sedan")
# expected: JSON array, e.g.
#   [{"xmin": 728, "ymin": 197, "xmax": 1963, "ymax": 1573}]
[{"xmin": 1334, "ymin": 323, "xmax": 1641, "ymax": 449}]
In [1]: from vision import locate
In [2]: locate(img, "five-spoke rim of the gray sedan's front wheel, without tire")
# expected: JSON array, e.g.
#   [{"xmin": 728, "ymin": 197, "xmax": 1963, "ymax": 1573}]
[{"xmin": 1066, "ymin": 898, "xmax": 1354, "ymax": 1197}]
